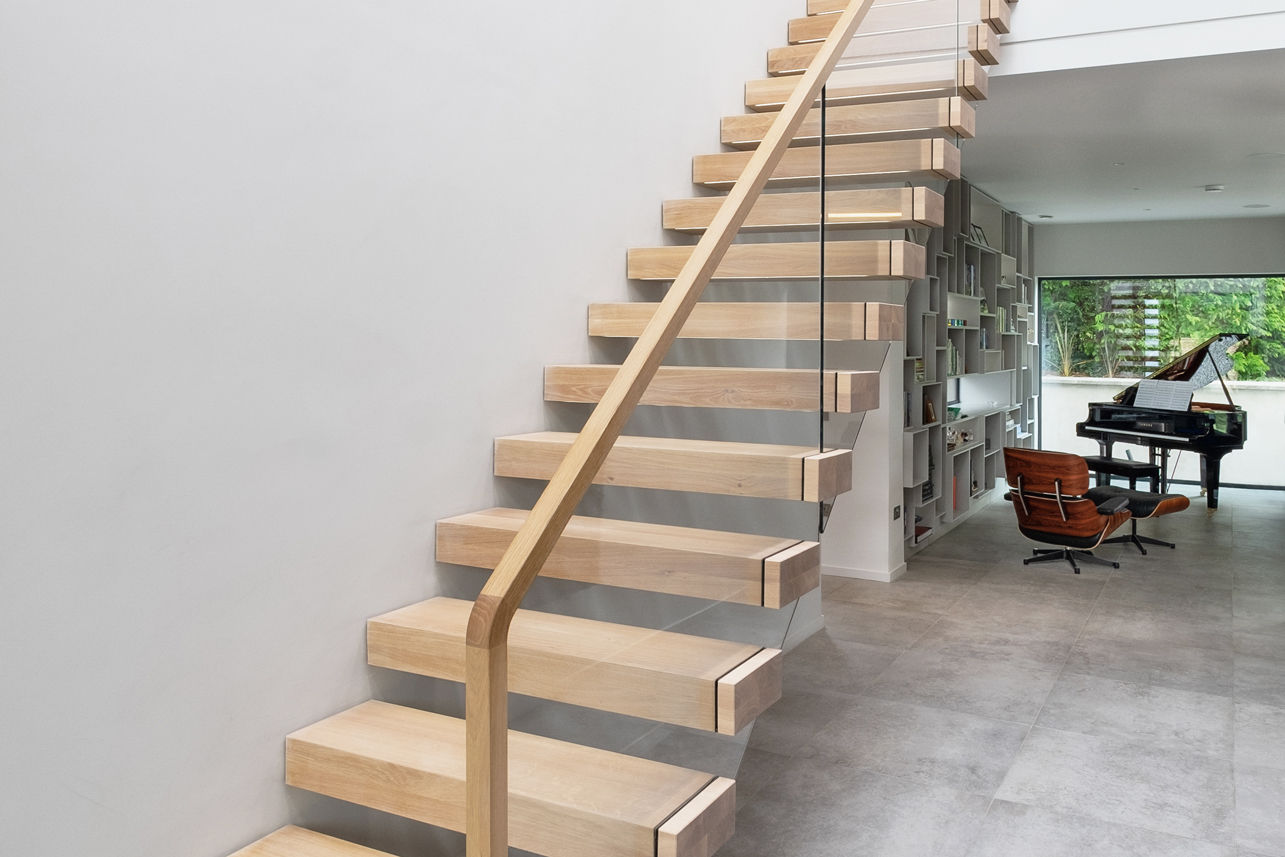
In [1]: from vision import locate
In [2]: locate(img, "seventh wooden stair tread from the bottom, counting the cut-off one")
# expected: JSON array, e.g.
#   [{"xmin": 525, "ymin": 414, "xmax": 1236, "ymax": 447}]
[{"xmin": 589, "ymin": 301, "xmax": 906, "ymax": 342}]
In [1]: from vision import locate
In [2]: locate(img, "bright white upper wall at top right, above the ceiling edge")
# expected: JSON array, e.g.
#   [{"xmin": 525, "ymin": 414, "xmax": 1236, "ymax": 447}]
[{"xmin": 992, "ymin": 0, "xmax": 1285, "ymax": 76}]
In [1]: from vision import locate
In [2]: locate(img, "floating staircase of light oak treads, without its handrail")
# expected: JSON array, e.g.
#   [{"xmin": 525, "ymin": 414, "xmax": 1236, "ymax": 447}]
[{"xmin": 235, "ymin": 0, "xmax": 1010, "ymax": 857}]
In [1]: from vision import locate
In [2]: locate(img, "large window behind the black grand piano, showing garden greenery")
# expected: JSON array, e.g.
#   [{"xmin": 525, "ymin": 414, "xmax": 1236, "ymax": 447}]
[{"xmin": 1040, "ymin": 276, "xmax": 1285, "ymax": 486}]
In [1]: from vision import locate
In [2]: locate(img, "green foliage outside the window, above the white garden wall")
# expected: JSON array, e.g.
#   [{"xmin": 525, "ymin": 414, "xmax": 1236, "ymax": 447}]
[{"xmin": 1040, "ymin": 276, "xmax": 1285, "ymax": 380}]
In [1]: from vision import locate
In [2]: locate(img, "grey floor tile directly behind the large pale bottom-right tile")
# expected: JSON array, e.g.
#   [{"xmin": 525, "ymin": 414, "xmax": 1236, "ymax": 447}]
[{"xmin": 1037, "ymin": 673, "xmax": 1235, "ymax": 758}]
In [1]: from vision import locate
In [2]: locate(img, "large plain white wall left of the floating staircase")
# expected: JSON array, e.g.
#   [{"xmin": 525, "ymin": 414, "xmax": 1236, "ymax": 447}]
[{"xmin": 0, "ymin": 0, "xmax": 799, "ymax": 857}]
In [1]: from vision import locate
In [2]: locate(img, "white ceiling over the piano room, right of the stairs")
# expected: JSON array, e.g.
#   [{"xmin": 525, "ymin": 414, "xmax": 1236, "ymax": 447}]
[{"xmin": 964, "ymin": 50, "xmax": 1285, "ymax": 224}]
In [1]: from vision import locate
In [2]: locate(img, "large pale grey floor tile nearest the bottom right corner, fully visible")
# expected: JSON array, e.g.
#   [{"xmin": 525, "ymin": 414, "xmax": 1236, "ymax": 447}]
[{"xmin": 996, "ymin": 726, "xmax": 1232, "ymax": 844}]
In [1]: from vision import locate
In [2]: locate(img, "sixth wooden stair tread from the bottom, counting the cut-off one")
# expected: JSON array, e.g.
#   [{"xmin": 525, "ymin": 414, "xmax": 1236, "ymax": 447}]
[{"xmin": 545, "ymin": 365, "xmax": 879, "ymax": 414}]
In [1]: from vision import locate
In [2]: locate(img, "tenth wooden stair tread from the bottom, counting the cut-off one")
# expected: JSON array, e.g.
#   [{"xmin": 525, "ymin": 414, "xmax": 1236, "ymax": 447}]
[{"xmin": 691, "ymin": 137, "xmax": 960, "ymax": 188}]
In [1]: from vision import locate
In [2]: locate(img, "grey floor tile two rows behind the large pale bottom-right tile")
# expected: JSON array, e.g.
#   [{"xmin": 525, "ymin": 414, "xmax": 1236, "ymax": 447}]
[{"xmin": 1067, "ymin": 636, "xmax": 1235, "ymax": 696}]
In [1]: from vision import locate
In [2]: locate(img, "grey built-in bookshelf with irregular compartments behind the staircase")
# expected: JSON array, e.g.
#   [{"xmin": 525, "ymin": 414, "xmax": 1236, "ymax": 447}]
[{"xmin": 902, "ymin": 180, "xmax": 1040, "ymax": 556}]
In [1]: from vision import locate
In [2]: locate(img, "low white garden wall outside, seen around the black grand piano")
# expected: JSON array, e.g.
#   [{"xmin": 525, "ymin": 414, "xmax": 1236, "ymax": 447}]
[{"xmin": 1040, "ymin": 375, "xmax": 1285, "ymax": 495}]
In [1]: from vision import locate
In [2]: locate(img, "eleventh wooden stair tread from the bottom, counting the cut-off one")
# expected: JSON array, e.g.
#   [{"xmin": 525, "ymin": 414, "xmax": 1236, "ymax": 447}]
[{"xmin": 722, "ymin": 95, "xmax": 977, "ymax": 149}]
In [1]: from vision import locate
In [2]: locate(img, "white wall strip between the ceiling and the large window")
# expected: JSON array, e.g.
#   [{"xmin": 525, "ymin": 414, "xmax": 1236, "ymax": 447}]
[{"xmin": 1034, "ymin": 217, "xmax": 1285, "ymax": 276}]
